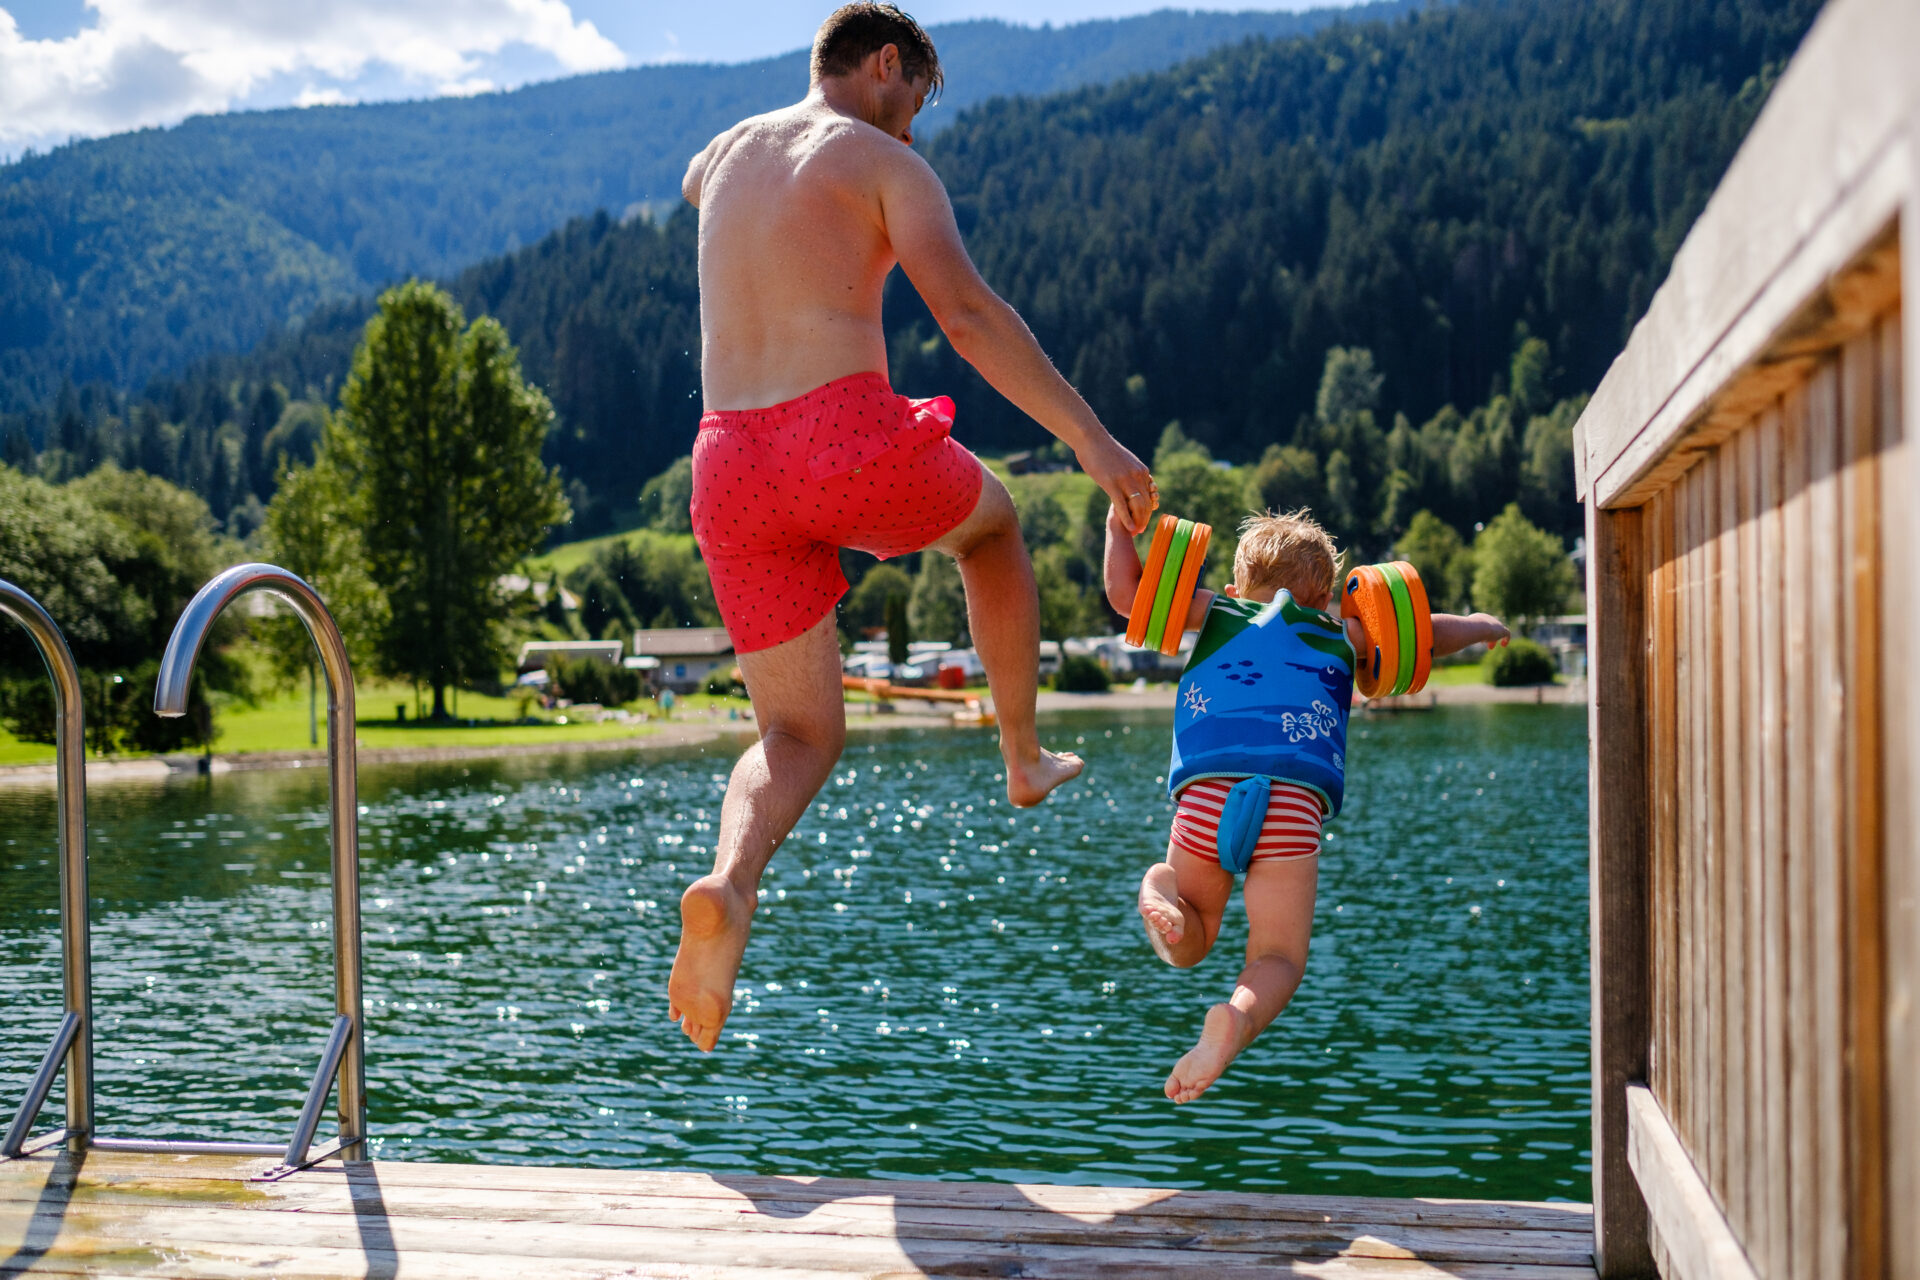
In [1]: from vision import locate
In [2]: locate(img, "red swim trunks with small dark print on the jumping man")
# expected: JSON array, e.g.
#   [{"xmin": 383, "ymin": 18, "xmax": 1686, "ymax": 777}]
[{"xmin": 693, "ymin": 374, "xmax": 983, "ymax": 652}]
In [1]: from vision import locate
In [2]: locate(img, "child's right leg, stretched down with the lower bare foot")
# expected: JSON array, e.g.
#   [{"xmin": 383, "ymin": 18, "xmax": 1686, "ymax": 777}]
[{"xmin": 1167, "ymin": 854, "xmax": 1319, "ymax": 1102}]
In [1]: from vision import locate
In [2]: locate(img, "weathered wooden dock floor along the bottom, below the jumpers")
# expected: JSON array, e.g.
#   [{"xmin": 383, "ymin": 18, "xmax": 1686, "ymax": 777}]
[{"xmin": 0, "ymin": 1151, "xmax": 1594, "ymax": 1280}]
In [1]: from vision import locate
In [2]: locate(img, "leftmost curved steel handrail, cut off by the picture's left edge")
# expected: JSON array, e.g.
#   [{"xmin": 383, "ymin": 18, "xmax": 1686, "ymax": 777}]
[{"xmin": 0, "ymin": 580, "xmax": 94, "ymax": 1157}]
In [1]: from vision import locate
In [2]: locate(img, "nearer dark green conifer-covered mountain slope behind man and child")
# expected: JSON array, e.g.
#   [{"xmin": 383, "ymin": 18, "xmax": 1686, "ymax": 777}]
[{"xmin": 8, "ymin": 0, "xmax": 1818, "ymax": 541}]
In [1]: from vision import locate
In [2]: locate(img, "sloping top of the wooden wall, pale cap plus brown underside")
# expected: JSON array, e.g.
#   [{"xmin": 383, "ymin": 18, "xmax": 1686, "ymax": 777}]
[{"xmin": 1574, "ymin": 0, "xmax": 1920, "ymax": 507}]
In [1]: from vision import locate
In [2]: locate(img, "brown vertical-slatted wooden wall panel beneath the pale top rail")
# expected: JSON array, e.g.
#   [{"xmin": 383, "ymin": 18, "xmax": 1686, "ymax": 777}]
[{"xmin": 1638, "ymin": 307, "xmax": 1920, "ymax": 1280}]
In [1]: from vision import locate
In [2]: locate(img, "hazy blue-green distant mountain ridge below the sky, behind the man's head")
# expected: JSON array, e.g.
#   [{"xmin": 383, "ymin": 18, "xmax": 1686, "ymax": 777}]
[{"xmin": 0, "ymin": 0, "xmax": 1411, "ymax": 411}]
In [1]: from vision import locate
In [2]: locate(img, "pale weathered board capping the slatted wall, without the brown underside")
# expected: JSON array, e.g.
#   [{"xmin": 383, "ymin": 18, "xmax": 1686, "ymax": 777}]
[{"xmin": 1586, "ymin": 0, "xmax": 1920, "ymax": 505}]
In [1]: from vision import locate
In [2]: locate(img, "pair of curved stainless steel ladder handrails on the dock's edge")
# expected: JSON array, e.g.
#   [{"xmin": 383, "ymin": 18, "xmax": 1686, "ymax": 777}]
[{"xmin": 0, "ymin": 564, "xmax": 367, "ymax": 1178}]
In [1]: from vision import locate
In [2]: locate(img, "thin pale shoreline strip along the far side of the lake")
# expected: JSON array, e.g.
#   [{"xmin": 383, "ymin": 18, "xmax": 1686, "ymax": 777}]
[{"xmin": 0, "ymin": 679, "xmax": 1586, "ymax": 787}]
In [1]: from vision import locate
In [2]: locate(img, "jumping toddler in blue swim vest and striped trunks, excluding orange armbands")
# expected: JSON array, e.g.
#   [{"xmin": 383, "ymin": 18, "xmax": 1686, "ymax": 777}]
[{"xmin": 1106, "ymin": 510, "xmax": 1507, "ymax": 1102}]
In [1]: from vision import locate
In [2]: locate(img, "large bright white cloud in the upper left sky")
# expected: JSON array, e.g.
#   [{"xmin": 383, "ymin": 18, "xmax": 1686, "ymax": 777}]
[{"xmin": 0, "ymin": 0, "xmax": 626, "ymax": 154}]
